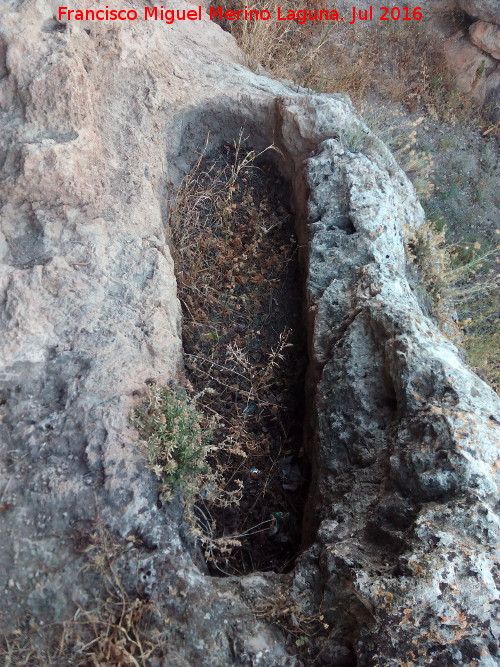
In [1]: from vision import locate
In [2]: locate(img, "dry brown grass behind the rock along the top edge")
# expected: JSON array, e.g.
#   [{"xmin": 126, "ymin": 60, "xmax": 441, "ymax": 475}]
[{"xmin": 221, "ymin": 0, "xmax": 472, "ymax": 122}]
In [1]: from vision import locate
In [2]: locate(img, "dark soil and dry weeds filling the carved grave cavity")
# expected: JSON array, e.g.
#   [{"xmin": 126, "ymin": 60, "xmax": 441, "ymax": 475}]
[{"xmin": 174, "ymin": 146, "xmax": 309, "ymax": 576}]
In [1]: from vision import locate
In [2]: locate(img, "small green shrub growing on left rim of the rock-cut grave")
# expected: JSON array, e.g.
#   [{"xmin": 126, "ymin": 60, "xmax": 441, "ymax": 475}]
[{"xmin": 132, "ymin": 386, "xmax": 212, "ymax": 500}]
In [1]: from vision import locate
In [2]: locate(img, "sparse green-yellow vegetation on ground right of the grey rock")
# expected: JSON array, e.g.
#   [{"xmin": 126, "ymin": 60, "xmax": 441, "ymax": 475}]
[{"xmin": 367, "ymin": 108, "xmax": 500, "ymax": 391}]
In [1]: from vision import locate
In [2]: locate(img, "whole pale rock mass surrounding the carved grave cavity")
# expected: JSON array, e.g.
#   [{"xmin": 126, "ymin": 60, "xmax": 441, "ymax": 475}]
[{"xmin": 0, "ymin": 1, "xmax": 500, "ymax": 667}]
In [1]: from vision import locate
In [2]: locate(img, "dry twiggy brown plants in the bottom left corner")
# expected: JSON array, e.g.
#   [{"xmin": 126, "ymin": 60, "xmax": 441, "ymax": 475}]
[{"xmin": 0, "ymin": 523, "xmax": 163, "ymax": 667}]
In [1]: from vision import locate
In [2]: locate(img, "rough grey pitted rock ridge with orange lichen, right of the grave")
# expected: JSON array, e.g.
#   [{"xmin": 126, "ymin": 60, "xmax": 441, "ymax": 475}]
[{"xmin": 282, "ymin": 103, "xmax": 500, "ymax": 666}]
